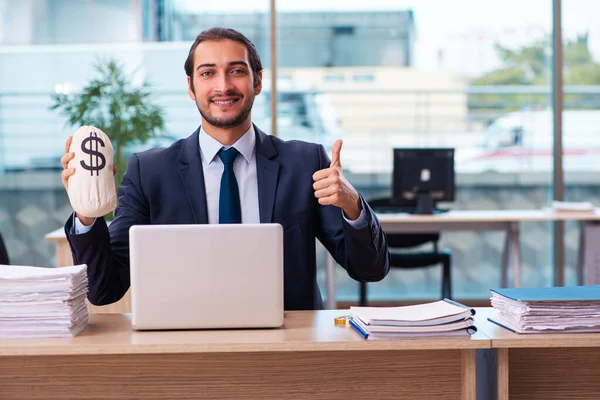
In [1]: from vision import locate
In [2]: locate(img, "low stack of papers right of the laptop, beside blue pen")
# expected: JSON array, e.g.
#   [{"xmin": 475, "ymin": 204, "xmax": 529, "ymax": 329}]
[{"xmin": 350, "ymin": 299, "xmax": 476, "ymax": 340}]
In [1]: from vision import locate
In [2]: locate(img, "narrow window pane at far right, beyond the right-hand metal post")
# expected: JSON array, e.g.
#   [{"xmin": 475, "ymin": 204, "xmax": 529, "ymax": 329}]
[{"xmin": 562, "ymin": 0, "xmax": 600, "ymax": 285}]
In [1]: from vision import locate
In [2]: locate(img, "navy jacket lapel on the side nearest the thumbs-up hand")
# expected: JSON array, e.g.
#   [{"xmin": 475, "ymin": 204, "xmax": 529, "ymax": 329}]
[{"xmin": 254, "ymin": 125, "xmax": 279, "ymax": 224}]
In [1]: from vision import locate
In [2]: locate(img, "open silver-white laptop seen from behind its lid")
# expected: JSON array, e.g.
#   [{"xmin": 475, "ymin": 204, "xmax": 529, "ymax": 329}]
[{"xmin": 129, "ymin": 224, "xmax": 283, "ymax": 330}]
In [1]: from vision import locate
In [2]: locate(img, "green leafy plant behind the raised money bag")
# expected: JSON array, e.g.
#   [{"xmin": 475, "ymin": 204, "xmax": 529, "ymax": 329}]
[{"xmin": 50, "ymin": 59, "xmax": 165, "ymax": 187}]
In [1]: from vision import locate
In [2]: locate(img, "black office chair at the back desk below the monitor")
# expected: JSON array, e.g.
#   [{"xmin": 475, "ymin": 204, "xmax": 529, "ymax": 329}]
[{"xmin": 360, "ymin": 198, "xmax": 452, "ymax": 306}]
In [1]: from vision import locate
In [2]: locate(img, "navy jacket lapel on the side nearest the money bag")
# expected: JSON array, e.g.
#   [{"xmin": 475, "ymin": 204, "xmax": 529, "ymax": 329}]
[{"xmin": 179, "ymin": 128, "xmax": 208, "ymax": 224}]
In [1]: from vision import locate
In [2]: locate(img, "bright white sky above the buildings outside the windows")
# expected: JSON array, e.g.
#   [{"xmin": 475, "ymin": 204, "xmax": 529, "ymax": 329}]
[{"xmin": 178, "ymin": 0, "xmax": 600, "ymax": 69}]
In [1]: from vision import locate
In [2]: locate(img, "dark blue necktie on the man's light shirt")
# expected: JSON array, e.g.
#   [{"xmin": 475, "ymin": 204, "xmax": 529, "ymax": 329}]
[{"xmin": 219, "ymin": 147, "xmax": 242, "ymax": 224}]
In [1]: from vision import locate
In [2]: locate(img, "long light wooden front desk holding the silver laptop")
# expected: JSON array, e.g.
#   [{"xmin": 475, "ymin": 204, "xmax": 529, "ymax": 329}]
[{"xmin": 0, "ymin": 310, "xmax": 490, "ymax": 400}]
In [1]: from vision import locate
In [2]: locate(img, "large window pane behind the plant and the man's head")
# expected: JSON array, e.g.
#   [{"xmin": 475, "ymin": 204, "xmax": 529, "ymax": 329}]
[{"xmin": 0, "ymin": 0, "xmax": 270, "ymax": 266}]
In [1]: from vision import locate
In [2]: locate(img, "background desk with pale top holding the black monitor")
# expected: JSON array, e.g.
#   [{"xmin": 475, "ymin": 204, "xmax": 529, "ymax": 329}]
[{"xmin": 327, "ymin": 209, "xmax": 600, "ymax": 309}]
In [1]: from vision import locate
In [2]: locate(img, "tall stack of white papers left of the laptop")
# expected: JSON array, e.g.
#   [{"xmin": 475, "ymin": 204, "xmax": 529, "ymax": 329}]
[{"xmin": 0, "ymin": 265, "xmax": 88, "ymax": 338}]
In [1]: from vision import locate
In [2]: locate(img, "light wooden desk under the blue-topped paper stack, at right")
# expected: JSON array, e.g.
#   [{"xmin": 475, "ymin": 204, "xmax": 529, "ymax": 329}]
[{"xmin": 475, "ymin": 309, "xmax": 600, "ymax": 400}]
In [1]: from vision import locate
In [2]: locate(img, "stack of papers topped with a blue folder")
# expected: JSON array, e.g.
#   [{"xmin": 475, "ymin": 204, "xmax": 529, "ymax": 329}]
[{"xmin": 488, "ymin": 285, "xmax": 600, "ymax": 333}]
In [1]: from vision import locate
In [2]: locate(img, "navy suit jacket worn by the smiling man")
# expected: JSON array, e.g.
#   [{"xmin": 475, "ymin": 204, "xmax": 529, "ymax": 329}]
[{"xmin": 65, "ymin": 127, "xmax": 389, "ymax": 310}]
